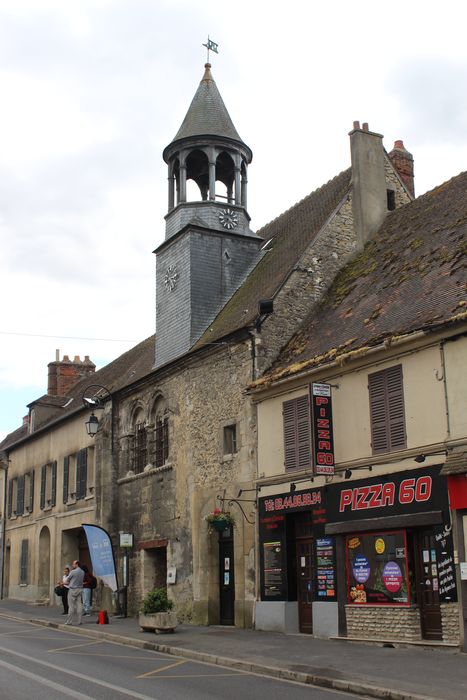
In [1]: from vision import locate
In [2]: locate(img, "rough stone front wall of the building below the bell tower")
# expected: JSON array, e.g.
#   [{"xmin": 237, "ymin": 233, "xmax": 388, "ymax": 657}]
[{"xmin": 110, "ymin": 340, "xmax": 256, "ymax": 626}]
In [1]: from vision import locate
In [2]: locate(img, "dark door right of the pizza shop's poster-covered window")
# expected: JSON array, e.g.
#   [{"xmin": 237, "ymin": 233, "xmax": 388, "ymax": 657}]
[{"xmin": 417, "ymin": 532, "xmax": 443, "ymax": 639}]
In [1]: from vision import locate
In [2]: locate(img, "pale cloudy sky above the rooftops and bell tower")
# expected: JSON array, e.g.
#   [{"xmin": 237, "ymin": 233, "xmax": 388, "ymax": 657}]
[{"xmin": 0, "ymin": 0, "xmax": 467, "ymax": 439}]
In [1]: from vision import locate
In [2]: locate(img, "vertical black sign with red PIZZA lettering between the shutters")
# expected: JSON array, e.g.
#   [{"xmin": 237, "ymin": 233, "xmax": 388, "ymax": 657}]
[{"xmin": 311, "ymin": 384, "xmax": 334, "ymax": 474}]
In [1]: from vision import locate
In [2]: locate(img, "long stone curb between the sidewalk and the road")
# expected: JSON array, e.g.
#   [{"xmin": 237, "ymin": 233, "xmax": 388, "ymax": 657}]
[{"xmin": 16, "ymin": 613, "xmax": 439, "ymax": 700}]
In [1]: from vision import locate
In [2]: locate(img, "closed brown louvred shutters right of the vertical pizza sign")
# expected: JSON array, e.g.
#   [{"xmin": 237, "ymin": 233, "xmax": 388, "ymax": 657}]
[{"xmin": 368, "ymin": 365, "xmax": 407, "ymax": 454}]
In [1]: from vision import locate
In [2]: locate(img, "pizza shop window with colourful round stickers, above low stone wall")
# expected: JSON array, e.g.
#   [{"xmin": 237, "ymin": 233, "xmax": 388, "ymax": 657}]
[{"xmin": 346, "ymin": 530, "xmax": 411, "ymax": 605}]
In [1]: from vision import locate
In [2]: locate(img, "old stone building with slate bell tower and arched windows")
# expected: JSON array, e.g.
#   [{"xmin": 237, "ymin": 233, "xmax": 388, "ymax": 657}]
[{"xmin": 2, "ymin": 67, "xmax": 411, "ymax": 627}]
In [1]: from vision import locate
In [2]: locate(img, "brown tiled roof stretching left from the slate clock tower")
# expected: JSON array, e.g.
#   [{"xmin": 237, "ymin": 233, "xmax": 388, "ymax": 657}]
[{"xmin": 0, "ymin": 335, "xmax": 154, "ymax": 451}]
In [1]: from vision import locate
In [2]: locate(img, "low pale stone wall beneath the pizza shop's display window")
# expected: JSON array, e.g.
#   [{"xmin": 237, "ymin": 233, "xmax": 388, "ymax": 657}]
[{"xmin": 345, "ymin": 605, "xmax": 422, "ymax": 641}]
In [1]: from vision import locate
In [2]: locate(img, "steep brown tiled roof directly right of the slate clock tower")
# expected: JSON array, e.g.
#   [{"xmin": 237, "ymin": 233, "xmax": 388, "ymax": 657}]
[{"xmin": 196, "ymin": 168, "xmax": 351, "ymax": 347}]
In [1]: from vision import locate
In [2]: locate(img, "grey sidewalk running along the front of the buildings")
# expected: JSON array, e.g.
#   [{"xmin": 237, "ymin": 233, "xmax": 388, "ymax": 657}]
[{"xmin": 0, "ymin": 600, "xmax": 467, "ymax": 700}]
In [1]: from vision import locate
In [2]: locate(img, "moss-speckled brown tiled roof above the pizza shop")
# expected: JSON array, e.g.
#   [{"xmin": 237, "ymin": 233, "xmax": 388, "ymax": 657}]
[{"xmin": 262, "ymin": 173, "xmax": 467, "ymax": 379}]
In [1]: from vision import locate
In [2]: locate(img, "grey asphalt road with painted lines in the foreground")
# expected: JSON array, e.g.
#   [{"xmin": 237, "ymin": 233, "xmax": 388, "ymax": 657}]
[{"xmin": 0, "ymin": 618, "xmax": 366, "ymax": 700}]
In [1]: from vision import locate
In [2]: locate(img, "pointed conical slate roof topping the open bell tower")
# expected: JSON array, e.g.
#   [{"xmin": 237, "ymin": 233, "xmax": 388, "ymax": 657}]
[{"xmin": 172, "ymin": 63, "xmax": 242, "ymax": 148}]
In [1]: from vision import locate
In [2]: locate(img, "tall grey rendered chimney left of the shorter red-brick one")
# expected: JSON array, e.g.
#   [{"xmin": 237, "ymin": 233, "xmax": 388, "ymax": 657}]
[{"xmin": 349, "ymin": 121, "xmax": 388, "ymax": 249}]
